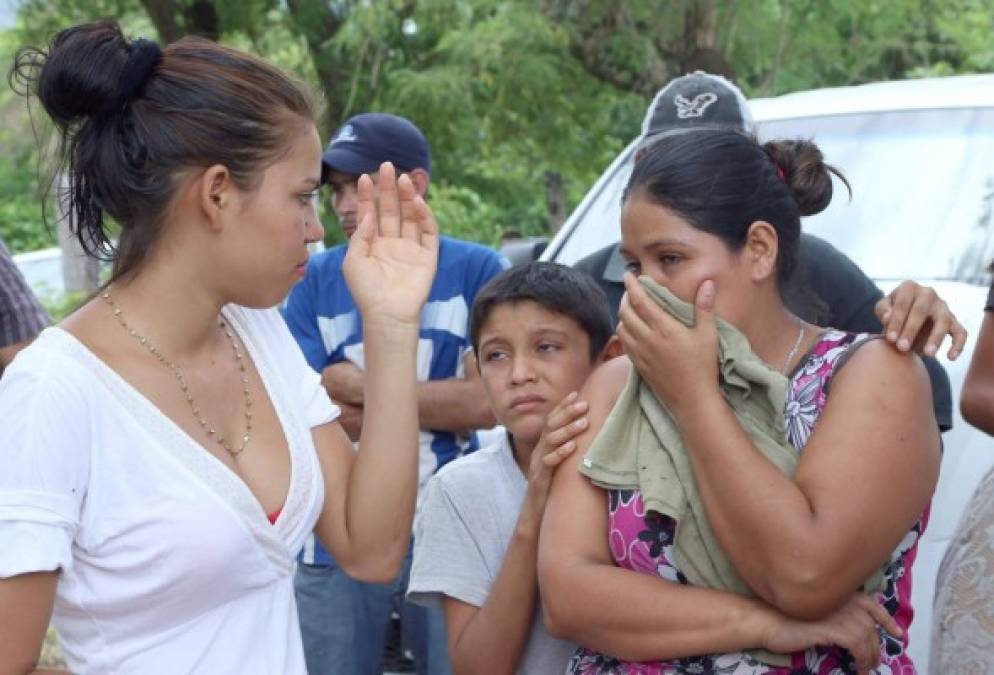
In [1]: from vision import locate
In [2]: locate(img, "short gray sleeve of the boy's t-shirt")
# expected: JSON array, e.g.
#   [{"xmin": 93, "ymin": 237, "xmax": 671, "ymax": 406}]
[{"xmin": 407, "ymin": 476, "xmax": 492, "ymax": 607}]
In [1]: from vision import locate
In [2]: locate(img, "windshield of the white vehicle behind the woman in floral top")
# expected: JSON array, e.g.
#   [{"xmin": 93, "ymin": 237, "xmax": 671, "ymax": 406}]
[{"xmin": 555, "ymin": 108, "xmax": 994, "ymax": 284}]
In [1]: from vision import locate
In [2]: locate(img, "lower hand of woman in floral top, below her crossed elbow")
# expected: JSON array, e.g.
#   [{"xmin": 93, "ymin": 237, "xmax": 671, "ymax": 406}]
[{"xmin": 763, "ymin": 593, "xmax": 901, "ymax": 675}]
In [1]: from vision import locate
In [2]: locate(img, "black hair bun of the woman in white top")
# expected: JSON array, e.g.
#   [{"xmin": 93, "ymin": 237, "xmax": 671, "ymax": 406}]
[{"xmin": 11, "ymin": 22, "xmax": 129, "ymax": 128}]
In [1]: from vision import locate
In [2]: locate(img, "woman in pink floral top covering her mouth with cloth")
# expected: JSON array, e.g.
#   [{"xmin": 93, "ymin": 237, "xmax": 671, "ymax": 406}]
[{"xmin": 539, "ymin": 128, "xmax": 939, "ymax": 675}]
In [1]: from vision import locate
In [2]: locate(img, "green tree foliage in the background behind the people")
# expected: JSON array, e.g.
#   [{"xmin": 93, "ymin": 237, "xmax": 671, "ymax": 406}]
[{"xmin": 0, "ymin": 0, "xmax": 994, "ymax": 254}]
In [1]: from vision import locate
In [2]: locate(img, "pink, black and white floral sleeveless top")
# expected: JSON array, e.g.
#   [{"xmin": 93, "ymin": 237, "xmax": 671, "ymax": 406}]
[{"xmin": 566, "ymin": 330, "xmax": 928, "ymax": 675}]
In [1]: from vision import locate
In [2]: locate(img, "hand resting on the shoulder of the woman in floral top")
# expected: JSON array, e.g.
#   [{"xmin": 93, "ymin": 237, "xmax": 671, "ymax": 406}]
[{"xmin": 873, "ymin": 281, "xmax": 966, "ymax": 360}]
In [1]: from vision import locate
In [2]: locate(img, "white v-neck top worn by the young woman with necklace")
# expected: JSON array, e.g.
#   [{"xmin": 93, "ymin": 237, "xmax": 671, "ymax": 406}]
[{"xmin": 0, "ymin": 306, "xmax": 338, "ymax": 675}]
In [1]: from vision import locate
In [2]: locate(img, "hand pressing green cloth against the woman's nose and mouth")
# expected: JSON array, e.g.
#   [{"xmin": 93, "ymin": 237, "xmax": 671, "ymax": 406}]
[{"xmin": 617, "ymin": 273, "xmax": 718, "ymax": 410}]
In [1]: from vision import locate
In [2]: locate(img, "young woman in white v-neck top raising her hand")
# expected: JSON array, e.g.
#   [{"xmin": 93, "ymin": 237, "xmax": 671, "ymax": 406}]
[{"xmin": 0, "ymin": 23, "xmax": 438, "ymax": 674}]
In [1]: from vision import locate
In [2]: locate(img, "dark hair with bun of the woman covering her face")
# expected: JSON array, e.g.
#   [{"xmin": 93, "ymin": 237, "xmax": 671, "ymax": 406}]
[{"xmin": 622, "ymin": 127, "xmax": 849, "ymax": 291}]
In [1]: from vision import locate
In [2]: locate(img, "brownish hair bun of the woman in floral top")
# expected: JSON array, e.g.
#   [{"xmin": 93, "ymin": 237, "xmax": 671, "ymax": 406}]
[{"xmin": 763, "ymin": 140, "xmax": 852, "ymax": 216}]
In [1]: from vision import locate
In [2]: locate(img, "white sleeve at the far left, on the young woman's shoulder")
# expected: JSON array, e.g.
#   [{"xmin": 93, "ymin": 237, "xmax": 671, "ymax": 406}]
[{"xmin": 0, "ymin": 348, "xmax": 92, "ymax": 578}]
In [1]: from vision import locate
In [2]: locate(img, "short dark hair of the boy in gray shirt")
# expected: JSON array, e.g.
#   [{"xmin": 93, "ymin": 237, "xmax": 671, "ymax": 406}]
[{"xmin": 469, "ymin": 261, "xmax": 614, "ymax": 361}]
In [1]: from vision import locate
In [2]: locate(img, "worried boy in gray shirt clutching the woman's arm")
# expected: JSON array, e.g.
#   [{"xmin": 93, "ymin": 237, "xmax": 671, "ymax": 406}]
[{"xmin": 408, "ymin": 262, "xmax": 620, "ymax": 675}]
